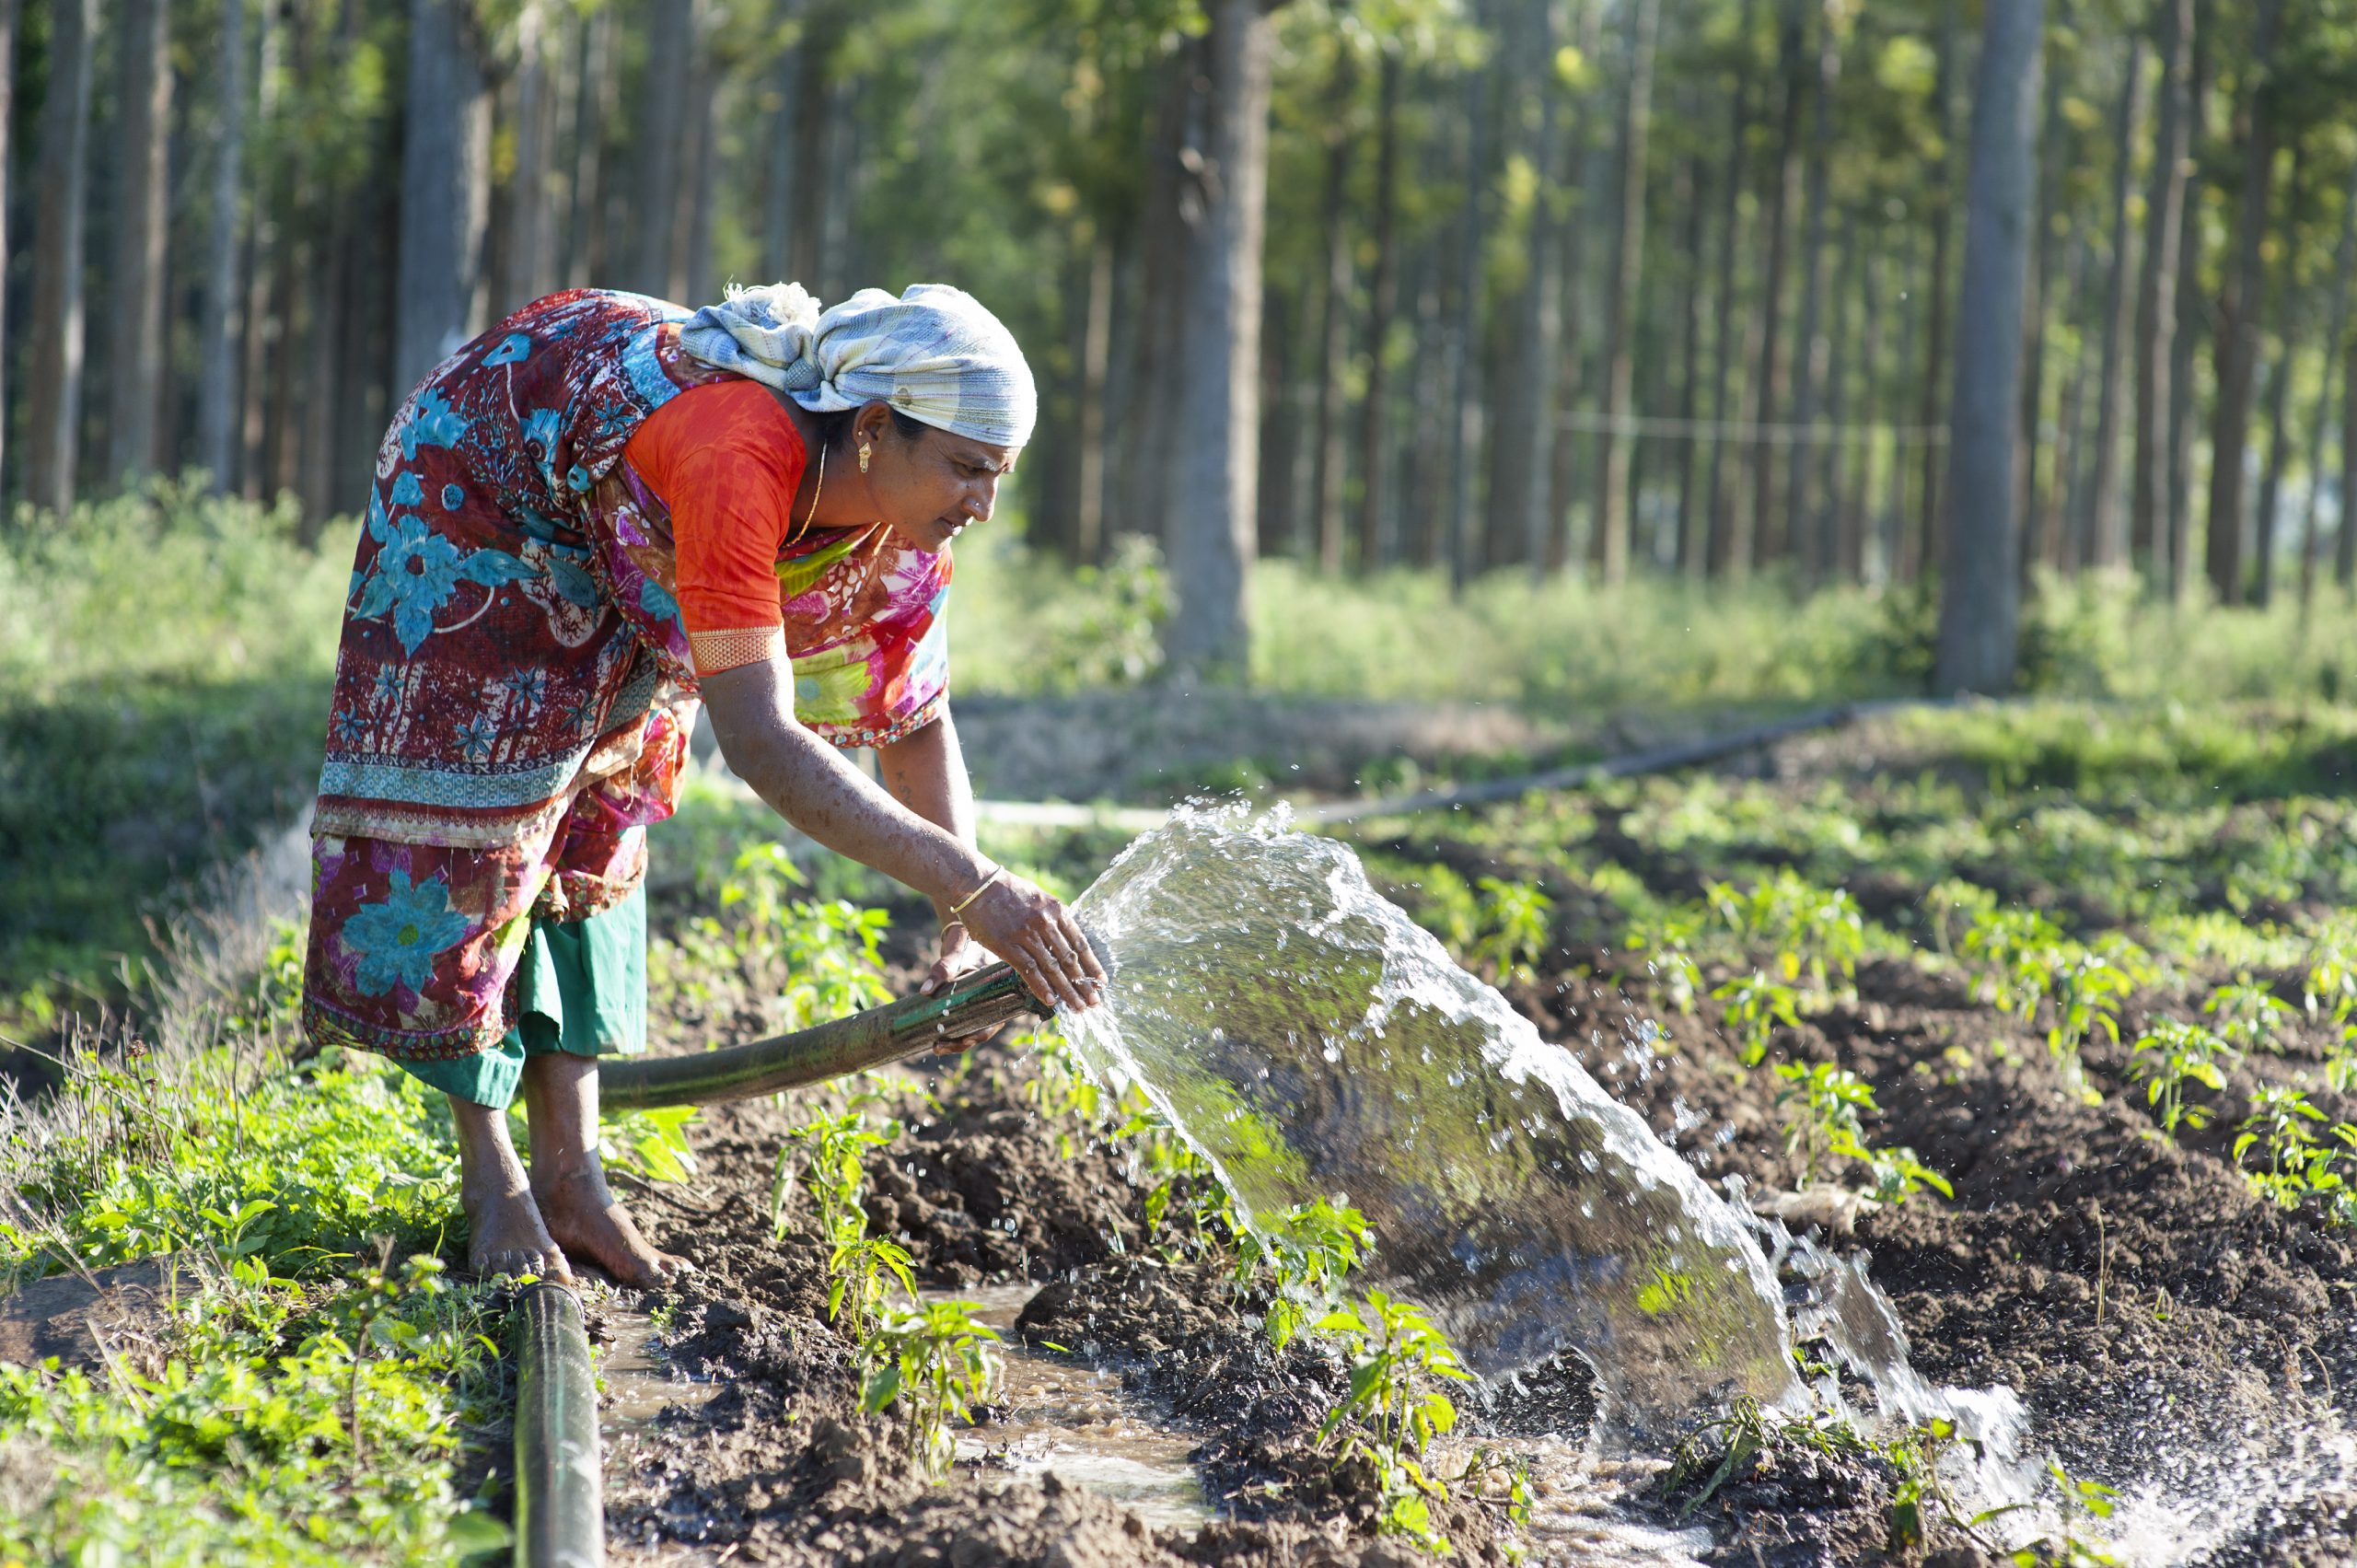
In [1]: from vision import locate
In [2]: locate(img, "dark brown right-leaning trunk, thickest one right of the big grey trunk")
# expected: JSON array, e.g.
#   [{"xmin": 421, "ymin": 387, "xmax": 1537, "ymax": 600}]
[{"xmin": 2204, "ymin": 0, "xmax": 2284, "ymax": 604}]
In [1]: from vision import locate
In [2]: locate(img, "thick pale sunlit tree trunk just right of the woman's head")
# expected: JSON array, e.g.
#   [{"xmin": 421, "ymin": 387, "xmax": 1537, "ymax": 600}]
[{"xmin": 1169, "ymin": 0, "xmax": 1275, "ymax": 679}]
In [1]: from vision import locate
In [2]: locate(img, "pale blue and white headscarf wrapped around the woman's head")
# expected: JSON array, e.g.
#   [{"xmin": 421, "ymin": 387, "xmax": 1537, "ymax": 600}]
[{"xmin": 679, "ymin": 283, "xmax": 1039, "ymax": 446}]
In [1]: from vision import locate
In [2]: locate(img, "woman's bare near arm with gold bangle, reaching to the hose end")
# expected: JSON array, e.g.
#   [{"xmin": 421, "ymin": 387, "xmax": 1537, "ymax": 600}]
[{"xmin": 698, "ymin": 657, "xmax": 1106, "ymax": 1009}]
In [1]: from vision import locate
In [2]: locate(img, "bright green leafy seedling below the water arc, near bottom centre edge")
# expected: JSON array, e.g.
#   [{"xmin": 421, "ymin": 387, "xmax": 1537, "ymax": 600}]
[{"xmin": 1318, "ymin": 1290, "xmax": 1473, "ymax": 1551}]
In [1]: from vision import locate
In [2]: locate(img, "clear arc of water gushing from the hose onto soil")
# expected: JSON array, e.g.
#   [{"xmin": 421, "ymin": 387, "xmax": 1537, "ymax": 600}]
[{"xmin": 1063, "ymin": 807, "xmax": 2017, "ymax": 1438}]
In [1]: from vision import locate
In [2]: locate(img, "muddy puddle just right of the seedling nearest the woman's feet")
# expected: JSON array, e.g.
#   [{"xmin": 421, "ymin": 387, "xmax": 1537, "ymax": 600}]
[{"xmin": 924, "ymin": 1285, "xmax": 1212, "ymax": 1535}]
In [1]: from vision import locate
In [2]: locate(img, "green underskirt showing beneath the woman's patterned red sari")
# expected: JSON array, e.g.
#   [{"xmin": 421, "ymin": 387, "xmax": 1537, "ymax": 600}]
[{"xmin": 401, "ymin": 887, "xmax": 645, "ymax": 1110}]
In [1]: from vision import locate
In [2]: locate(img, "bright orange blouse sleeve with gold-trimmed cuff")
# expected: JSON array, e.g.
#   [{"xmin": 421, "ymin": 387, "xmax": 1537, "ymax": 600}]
[{"xmin": 622, "ymin": 379, "xmax": 808, "ymax": 674}]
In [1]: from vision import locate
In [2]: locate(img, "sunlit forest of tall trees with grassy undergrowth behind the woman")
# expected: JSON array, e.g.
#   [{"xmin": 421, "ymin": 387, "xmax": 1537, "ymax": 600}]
[{"xmin": 0, "ymin": 0, "xmax": 2357, "ymax": 1021}]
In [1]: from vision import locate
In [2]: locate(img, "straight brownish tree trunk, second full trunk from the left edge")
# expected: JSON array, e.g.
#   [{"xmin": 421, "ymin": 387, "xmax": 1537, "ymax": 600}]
[{"xmin": 106, "ymin": 0, "xmax": 172, "ymax": 483}]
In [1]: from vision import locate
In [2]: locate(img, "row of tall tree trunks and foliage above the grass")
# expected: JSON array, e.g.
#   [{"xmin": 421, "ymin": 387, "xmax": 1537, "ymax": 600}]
[{"xmin": 0, "ymin": 0, "xmax": 2357, "ymax": 679}]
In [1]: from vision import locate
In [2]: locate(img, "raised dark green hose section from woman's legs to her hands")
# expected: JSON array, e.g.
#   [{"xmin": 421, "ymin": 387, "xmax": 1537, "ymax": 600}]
[{"xmin": 598, "ymin": 964, "xmax": 1049, "ymax": 1110}]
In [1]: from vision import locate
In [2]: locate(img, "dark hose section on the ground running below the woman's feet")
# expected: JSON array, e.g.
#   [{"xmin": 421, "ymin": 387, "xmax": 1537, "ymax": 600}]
[{"xmin": 509, "ymin": 1281, "xmax": 606, "ymax": 1568}]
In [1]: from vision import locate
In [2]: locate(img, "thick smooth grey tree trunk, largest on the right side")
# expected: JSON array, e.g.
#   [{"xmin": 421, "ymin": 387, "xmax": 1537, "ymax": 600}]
[{"xmin": 1933, "ymin": 0, "xmax": 2046, "ymax": 695}]
